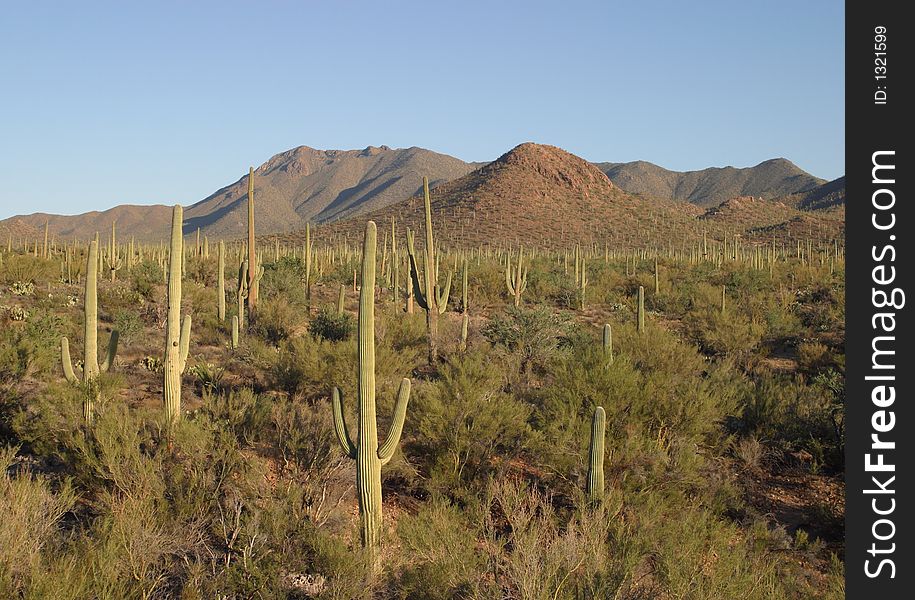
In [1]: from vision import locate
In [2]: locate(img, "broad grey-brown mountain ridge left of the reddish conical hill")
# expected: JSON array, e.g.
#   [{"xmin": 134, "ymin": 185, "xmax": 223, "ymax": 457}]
[{"xmin": 0, "ymin": 146, "xmax": 478, "ymax": 241}]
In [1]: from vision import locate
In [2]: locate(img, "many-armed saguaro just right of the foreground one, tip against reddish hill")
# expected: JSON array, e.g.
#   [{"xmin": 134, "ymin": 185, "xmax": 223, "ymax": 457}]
[{"xmin": 407, "ymin": 177, "xmax": 452, "ymax": 363}]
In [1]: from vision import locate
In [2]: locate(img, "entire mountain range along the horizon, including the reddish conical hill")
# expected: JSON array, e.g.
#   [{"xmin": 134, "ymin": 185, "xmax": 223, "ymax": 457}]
[{"xmin": 0, "ymin": 143, "xmax": 844, "ymax": 245}]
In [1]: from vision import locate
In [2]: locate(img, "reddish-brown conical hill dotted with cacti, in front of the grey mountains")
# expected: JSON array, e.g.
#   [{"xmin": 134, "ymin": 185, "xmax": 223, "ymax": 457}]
[{"xmin": 298, "ymin": 142, "xmax": 701, "ymax": 248}]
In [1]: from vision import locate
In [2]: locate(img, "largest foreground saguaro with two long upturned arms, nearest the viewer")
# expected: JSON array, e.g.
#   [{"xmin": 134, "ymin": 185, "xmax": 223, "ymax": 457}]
[{"xmin": 332, "ymin": 221, "xmax": 410, "ymax": 566}]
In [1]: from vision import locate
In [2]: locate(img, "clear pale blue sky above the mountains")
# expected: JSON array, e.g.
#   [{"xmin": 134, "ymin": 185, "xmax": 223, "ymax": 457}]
[{"xmin": 0, "ymin": 0, "xmax": 845, "ymax": 218}]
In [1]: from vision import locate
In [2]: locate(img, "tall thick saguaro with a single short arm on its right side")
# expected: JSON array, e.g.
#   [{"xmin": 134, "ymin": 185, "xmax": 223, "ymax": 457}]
[{"xmin": 162, "ymin": 204, "xmax": 191, "ymax": 425}]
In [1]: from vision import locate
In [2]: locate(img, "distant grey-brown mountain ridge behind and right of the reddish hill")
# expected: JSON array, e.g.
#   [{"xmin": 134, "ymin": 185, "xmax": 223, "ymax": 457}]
[{"xmin": 596, "ymin": 158, "xmax": 825, "ymax": 208}]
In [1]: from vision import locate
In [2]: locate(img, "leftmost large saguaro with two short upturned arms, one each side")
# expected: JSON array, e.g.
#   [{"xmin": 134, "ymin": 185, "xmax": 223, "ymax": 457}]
[{"xmin": 60, "ymin": 240, "xmax": 118, "ymax": 423}]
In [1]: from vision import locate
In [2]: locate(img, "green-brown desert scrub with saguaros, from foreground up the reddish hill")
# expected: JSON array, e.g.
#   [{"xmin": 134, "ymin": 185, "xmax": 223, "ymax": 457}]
[{"xmin": 0, "ymin": 180, "xmax": 845, "ymax": 600}]
